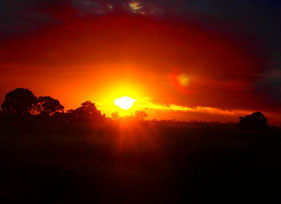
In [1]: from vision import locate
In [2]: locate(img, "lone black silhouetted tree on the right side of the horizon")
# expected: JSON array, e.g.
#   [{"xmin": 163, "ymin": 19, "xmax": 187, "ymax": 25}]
[{"xmin": 239, "ymin": 112, "xmax": 268, "ymax": 130}]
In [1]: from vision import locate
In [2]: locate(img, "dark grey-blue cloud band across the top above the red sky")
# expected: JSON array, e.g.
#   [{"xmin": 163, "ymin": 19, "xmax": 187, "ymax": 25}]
[{"xmin": 0, "ymin": 0, "xmax": 281, "ymax": 55}]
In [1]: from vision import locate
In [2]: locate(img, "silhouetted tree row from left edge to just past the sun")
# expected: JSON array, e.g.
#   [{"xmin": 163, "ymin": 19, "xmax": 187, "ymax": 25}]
[{"xmin": 1, "ymin": 88, "xmax": 148, "ymax": 120}]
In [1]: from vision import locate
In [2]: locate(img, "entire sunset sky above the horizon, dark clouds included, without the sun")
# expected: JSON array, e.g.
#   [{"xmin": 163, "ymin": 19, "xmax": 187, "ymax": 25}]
[{"xmin": 0, "ymin": 0, "xmax": 281, "ymax": 125}]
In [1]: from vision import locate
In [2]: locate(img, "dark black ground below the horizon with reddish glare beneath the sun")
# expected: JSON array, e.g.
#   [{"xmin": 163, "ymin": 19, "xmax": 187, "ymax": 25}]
[{"xmin": 0, "ymin": 116, "xmax": 281, "ymax": 204}]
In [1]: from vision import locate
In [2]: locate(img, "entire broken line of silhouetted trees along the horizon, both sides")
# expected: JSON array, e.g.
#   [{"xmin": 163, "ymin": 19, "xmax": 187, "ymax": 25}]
[{"xmin": 1, "ymin": 88, "xmax": 269, "ymax": 130}]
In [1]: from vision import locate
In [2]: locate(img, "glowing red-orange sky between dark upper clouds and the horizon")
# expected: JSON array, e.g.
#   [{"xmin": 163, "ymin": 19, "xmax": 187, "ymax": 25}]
[{"xmin": 0, "ymin": 1, "xmax": 281, "ymax": 125}]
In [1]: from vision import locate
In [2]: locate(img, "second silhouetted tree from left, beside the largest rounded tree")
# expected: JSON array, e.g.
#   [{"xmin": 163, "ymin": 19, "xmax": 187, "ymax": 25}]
[{"xmin": 38, "ymin": 96, "xmax": 64, "ymax": 115}]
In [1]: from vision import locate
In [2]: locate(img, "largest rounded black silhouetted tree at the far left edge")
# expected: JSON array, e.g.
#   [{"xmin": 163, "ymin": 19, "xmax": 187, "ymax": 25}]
[{"xmin": 1, "ymin": 88, "xmax": 38, "ymax": 114}]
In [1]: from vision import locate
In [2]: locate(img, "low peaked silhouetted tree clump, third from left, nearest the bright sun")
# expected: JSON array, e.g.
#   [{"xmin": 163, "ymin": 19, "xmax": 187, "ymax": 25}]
[{"xmin": 68, "ymin": 101, "xmax": 102, "ymax": 119}]
